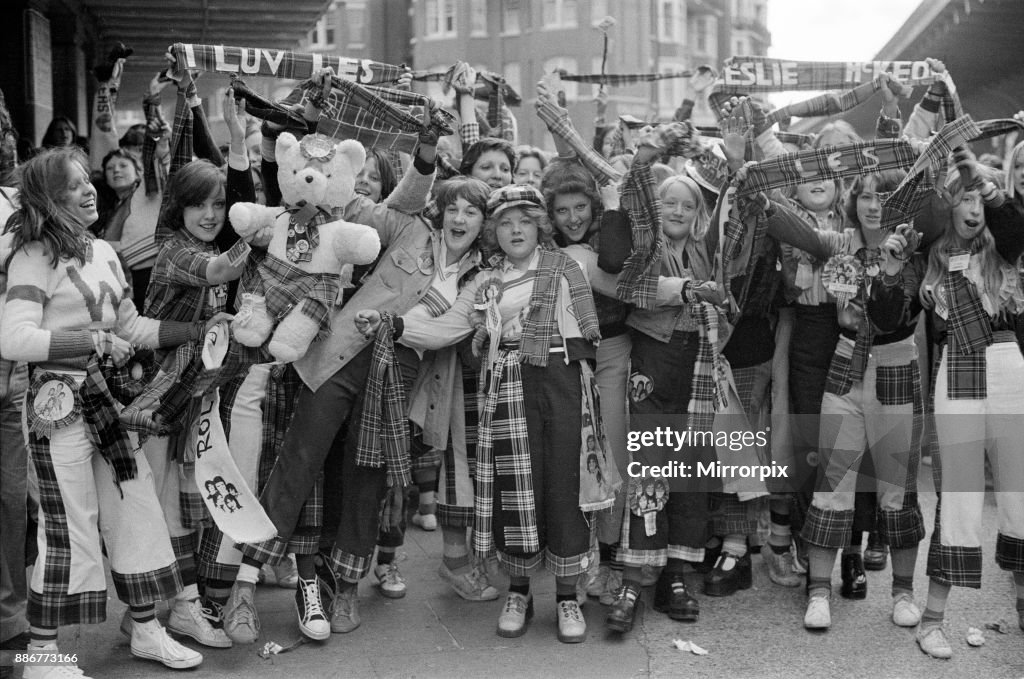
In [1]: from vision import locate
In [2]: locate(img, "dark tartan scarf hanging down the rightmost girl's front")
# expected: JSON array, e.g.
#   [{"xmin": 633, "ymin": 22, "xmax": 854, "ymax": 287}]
[{"xmin": 944, "ymin": 244, "xmax": 992, "ymax": 399}]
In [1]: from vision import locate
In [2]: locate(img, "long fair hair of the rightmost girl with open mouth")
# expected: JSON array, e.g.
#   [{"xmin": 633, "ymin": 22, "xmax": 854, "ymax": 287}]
[{"xmin": 920, "ymin": 166, "xmax": 1016, "ymax": 308}]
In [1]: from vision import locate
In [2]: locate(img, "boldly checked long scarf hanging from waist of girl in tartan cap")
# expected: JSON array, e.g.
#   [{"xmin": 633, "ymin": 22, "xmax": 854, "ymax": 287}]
[{"xmin": 472, "ymin": 349, "xmax": 541, "ymax": 554}]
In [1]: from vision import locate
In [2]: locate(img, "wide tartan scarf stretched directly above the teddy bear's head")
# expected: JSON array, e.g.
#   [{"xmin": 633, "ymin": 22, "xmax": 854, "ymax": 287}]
[{"xmin": 281, "ymin": 78, "xmax": 455, "ymax": 154}]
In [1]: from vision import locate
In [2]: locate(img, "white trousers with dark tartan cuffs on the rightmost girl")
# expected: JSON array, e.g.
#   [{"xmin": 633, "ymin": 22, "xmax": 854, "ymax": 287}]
[{"xmin": 928, "ymin": 342, "xmax": 1024, "ymax": 589}]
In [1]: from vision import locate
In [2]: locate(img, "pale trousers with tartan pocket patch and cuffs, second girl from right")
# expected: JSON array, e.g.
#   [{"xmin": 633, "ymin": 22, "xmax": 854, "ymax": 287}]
[{"xmin": 802, "ymin": 335, "xmax": 925, "ymax": 549}]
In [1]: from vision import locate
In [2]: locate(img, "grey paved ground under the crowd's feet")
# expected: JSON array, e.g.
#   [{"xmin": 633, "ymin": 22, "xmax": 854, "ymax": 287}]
[{"xmin": 15, "ymin": 467, "xmax": 1024, "ymax": 679}]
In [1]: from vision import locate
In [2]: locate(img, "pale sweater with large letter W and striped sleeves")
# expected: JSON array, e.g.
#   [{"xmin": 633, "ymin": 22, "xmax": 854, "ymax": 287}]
[{"xmin": 0, "ymin": 240, "xmax": 188, "ymax": 363}]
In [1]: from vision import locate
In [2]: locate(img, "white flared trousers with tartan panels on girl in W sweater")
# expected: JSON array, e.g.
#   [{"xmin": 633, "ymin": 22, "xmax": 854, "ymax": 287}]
[{"xmin": 26, "ymin": 373, "xmax": 181, "ymax": 628}]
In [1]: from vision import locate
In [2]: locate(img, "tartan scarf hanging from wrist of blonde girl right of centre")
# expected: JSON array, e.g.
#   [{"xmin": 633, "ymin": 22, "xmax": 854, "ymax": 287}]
[{"xmin": 686, "ymin": 302, "xmax": 729, "ymax": 431}]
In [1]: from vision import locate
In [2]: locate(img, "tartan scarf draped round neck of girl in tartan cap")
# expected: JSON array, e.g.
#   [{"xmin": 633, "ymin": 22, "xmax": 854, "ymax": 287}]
[{"xmin": 519, "ymin": 249, "xmax": 601, "ymax": 367}]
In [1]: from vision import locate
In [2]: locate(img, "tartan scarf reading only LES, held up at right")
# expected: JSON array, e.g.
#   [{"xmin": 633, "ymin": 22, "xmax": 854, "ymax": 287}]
[{"xmin": 738, "ymin": 139, "xmax": 916, "ymax": 196}]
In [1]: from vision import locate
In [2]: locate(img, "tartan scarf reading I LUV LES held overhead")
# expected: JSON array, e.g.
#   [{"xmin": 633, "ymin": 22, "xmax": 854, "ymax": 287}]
[{"xmin": 168, "ymin": 42, "xmax": 404, "ymax": 83}]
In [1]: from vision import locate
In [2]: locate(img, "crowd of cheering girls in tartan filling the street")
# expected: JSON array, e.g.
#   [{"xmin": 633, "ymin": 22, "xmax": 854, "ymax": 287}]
[{"xmin": 0, "ymin": 53, "xmax": 1024, "ymax": 677}]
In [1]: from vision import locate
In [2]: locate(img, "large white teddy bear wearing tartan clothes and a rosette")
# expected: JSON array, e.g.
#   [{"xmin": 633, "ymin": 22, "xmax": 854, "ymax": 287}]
[{"xmin": 229, "ymin": 132, "xmax": 381, "ymax": 363}]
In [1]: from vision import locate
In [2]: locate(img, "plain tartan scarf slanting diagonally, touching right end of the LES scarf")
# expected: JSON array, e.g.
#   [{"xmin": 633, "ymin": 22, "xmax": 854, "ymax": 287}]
[{"xmin": 882, "ymin": 116, "xmax": 981, "ymax": 229}]
